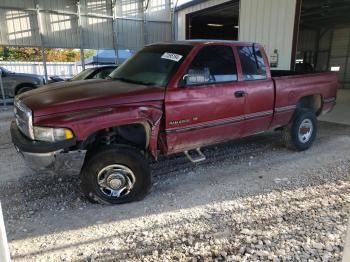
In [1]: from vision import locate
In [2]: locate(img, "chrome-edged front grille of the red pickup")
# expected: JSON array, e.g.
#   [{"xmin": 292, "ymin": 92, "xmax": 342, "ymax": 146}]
[{"xmin": 14, "ymin": 100, "xmax": 34, "ymax": 139}]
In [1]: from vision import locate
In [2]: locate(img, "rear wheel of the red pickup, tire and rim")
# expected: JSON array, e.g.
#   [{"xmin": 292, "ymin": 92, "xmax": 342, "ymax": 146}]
[{"xmin": 282, "ymin": 109, "xmax": 317, "ymax": 151}]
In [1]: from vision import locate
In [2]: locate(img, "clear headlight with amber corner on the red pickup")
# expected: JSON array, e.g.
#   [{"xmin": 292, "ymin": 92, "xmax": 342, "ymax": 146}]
[{"xmin": 34, "ymin": 126, "xmax": 74, "ymax": 142}]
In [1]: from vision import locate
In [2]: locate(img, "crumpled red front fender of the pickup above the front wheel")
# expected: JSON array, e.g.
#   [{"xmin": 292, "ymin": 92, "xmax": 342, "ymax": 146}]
[{"xmin": 34, "ymin": 102, "xmax": 163, "ymax": 158}]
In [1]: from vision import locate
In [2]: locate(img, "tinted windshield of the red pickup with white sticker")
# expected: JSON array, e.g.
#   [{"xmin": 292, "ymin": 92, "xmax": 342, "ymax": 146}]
[{"xmin": 110, "ymin": 44, "xmax": 192, "ymax": 86}]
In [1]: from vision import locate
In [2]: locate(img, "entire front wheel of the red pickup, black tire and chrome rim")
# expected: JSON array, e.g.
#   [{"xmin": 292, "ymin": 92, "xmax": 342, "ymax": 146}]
[{"xmin": 81, "ymin": 145, "xmax": 152, "ymax": 204}]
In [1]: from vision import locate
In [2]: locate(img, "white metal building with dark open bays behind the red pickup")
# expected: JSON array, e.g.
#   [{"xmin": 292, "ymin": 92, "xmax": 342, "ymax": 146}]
[{"xmin": 175, "ymin": 0, "xmax": 350, "ymax": 88}]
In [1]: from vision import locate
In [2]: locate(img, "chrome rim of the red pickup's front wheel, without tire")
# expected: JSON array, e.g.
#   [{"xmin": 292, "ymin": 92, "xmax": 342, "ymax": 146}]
[{"xmin": 97, "ymin": 164, "xmax": 136, "ymax": 198}]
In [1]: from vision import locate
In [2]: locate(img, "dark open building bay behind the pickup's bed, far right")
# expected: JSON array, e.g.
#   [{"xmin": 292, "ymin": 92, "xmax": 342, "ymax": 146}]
[{"xmin": 297, "ymin": 0, "xmax": 350, "ymax": 89}]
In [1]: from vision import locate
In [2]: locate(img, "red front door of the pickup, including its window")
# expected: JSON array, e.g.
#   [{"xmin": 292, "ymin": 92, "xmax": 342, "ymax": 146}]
[{"xmin": 165, "ymin": 45, "xmax": 245, "ymax": 154}]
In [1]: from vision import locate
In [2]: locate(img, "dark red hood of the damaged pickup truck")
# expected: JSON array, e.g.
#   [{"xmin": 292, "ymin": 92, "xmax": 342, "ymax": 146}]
[{"xmin": 18, "ymin": 79, "xmax": 165, "ymax": 117}]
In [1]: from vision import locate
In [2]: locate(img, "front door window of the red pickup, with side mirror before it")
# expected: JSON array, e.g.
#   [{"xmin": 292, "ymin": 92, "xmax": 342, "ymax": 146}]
[{"xmin": 184, "ymin": 45, "xmax": 237, "ymax": 85}]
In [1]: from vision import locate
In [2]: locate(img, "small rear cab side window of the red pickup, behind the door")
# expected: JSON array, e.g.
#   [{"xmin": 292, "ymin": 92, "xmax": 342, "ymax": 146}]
[{"xmin": 237, "ymin": 46, "xmax": 266, "ymax": 80}]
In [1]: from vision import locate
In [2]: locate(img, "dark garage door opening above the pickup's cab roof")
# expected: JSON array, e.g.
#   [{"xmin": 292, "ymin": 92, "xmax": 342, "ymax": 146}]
[{"xmin": 186, "ymin": 1, "xmax": 239, "ymax": 40}]
